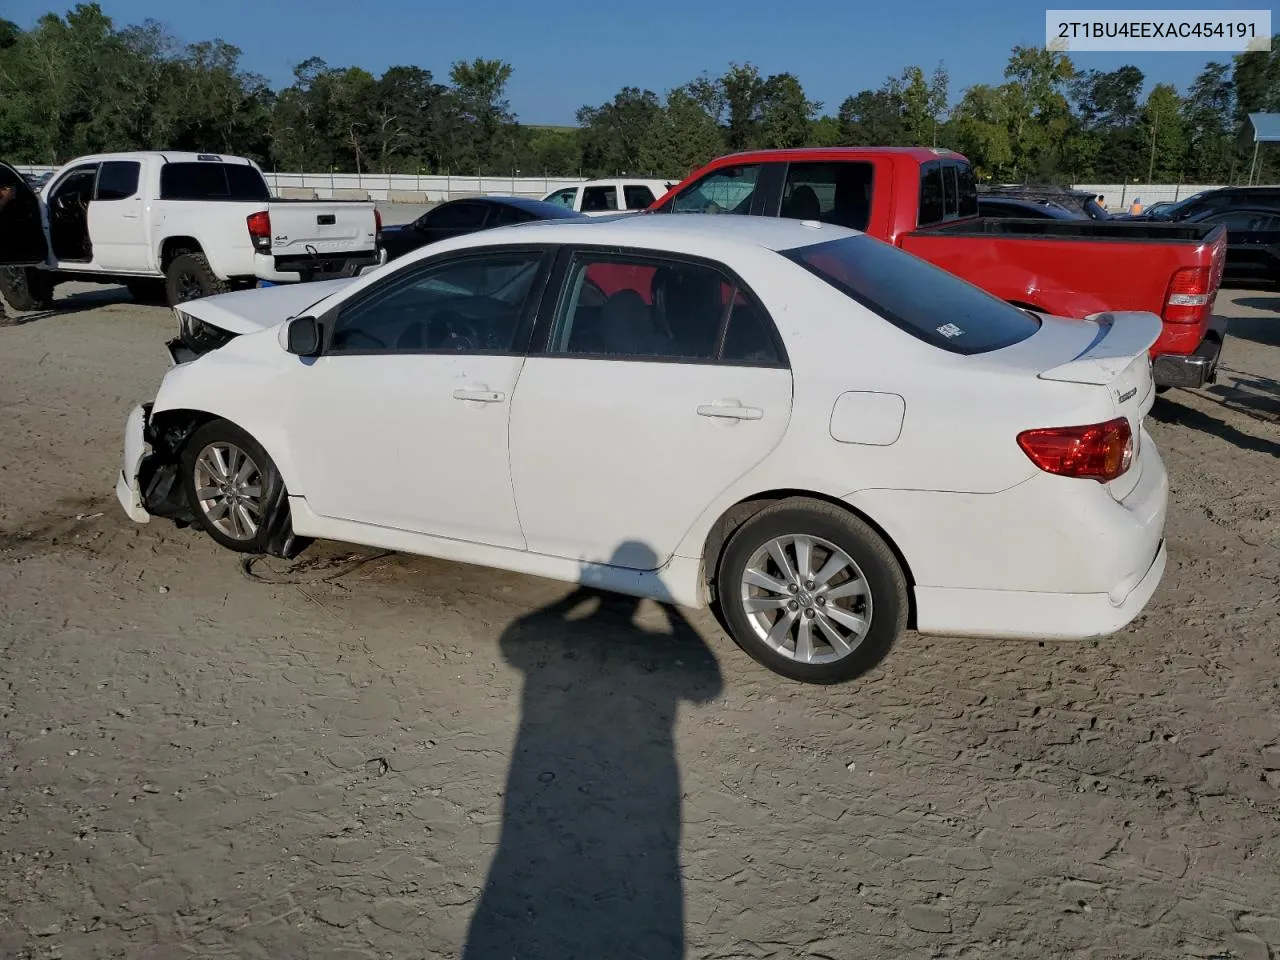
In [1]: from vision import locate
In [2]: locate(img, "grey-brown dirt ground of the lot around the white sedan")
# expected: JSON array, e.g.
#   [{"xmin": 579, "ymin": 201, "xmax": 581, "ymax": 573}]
[{"xmin": 0, "ymin": 281, "xmax": 1280, "ymax": 960}]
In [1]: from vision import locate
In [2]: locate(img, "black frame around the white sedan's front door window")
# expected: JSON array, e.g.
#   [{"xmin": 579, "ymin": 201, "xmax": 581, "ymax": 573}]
[{"xmin": 316, "ymin": 243, "xmax": 556, "ymax": 358}]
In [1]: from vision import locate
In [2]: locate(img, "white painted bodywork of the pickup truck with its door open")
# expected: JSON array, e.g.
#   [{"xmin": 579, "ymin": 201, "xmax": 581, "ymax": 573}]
[{"xmin": 0, "ymin": 152, "xmax": 381, "ymax": 289}]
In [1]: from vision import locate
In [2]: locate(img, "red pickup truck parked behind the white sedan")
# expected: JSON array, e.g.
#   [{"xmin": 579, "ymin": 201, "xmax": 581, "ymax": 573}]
[{"xmin": 649, "ymin": 147, "xmax": 1226, "ymax": 387}]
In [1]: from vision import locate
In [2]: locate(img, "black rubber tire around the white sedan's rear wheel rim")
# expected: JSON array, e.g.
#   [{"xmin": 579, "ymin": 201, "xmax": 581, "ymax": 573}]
[{"xmin": 716, "ymin": 498, "xmax": 910, "ymax": 684}]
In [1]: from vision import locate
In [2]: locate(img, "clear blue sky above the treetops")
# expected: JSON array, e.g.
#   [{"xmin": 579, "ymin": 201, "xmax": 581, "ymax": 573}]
[{"xmin": 4, "ymin": 0, "xmax": 1266, "ymax": 124}]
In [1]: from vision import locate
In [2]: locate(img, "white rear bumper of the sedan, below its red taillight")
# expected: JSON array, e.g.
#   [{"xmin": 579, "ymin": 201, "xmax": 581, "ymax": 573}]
[{"xmin": 850, "ymin": 430, "xmax": 1169, "ymax": 639}]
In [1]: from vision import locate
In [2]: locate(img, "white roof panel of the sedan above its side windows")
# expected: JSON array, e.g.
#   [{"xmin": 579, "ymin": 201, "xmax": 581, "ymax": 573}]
[{"xmin": 431, "ymin": 212, "xmax": 861, "ymax": 259}]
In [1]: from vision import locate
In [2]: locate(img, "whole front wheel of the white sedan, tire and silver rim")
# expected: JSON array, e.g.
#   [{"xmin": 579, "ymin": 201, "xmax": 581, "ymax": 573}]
[{"xmin": 182, "ymin": 420, "xmax": 308, "ymax": 557}]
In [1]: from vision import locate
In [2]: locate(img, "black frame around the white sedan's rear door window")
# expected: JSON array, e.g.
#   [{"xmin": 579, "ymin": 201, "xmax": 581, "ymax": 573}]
[{"xmin": 529, "ymin": 243, "xmax": 791, "ymax": 370}]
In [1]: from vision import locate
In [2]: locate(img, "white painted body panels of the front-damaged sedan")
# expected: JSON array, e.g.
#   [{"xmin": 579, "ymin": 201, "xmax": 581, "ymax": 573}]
[{"xmin": 116, "ymin": 215, "xmax": 1169, "ymax": 680}]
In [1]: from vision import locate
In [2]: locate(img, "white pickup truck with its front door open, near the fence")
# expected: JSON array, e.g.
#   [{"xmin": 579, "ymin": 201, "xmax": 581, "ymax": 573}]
[{"xmin": 0, "ymin": 152, "xmax": 385, "ymax": 310}]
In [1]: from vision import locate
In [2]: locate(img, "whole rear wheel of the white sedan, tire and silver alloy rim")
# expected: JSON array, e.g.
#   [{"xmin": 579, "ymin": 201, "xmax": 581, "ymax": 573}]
[{"xmin": 717, "ymin": 498, "xmax": 909, "ymax": 684}]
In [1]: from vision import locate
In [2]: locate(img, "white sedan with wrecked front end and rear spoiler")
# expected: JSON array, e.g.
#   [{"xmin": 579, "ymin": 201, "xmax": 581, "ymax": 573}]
[{"xmin": 116, "ymin": 215, "xmax": 1169, "ymax": 682}]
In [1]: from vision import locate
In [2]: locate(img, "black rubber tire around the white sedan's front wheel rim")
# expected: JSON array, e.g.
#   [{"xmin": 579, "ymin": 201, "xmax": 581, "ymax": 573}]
[{"xmin": 182, "ymin": 420, "xmax": 310, "ymax": 557}]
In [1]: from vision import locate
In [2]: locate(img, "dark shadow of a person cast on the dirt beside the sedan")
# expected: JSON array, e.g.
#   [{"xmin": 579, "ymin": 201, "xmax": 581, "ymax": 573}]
[{"xmin": 462, "ymin": 544, "xmax": 722, "ymax": 960}]
